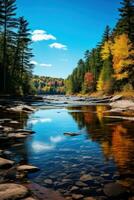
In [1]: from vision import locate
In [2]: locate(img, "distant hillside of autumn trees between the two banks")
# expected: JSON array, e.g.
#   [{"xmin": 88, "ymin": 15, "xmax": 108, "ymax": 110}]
[{"xmin": 32, "ymin": 76, "xmax": 65, "ymax": 94}]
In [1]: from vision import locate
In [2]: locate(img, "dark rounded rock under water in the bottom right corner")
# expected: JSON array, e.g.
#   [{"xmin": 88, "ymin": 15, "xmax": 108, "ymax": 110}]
[{"xmin": 103, "ymin": 183, "xmax": 126, "ymax": 197}]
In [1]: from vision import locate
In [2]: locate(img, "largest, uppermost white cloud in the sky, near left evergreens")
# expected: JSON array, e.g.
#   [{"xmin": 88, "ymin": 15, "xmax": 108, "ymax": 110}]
[{"xmin": 32, "ymin": 30, "xmax": 56, "ymax": 42}]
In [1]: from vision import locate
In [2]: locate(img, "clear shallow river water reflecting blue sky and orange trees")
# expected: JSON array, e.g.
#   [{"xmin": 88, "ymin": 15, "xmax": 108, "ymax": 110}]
[{"xmin": 10, "ymin": 106, "xmax": 134, "ymax": 197}]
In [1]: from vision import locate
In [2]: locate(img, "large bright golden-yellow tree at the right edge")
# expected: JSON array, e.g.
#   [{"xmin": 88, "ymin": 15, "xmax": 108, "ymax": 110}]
[{"xmin": 112, "ymin": 34, "xmax": 134, "ymax": 80}]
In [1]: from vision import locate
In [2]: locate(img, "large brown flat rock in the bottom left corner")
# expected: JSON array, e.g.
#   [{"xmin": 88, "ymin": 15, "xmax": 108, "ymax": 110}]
[{"xmin": 0, "ymin": 183, "xmax": 28, "ymax": 200}]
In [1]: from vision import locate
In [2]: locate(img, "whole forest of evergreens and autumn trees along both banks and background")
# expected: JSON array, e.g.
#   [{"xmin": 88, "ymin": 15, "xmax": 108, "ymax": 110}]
[{"xmin": 0, "ymin": 0, "xmax": 134, "ymax": 95}]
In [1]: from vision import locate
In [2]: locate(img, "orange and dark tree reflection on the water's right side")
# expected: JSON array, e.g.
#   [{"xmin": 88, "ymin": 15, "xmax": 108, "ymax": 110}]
[{"xmin": 70, "ymin": 106, "xmax": 134, "ymax": 185}]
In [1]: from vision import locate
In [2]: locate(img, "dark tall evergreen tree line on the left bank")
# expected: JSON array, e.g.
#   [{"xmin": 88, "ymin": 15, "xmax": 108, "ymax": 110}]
[{"xmin": 0, "ymin": 0, "xmax": 33, "ymax": 95}]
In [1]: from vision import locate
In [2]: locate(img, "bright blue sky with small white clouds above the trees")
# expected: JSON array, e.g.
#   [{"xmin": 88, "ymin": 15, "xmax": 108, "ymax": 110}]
[{"xmin": 17, "ymin": 0, "xmax": 120, "ymax": 78}]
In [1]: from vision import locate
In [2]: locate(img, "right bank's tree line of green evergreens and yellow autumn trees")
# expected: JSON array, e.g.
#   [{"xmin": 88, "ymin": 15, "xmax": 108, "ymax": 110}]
[{"xmin": 65, "ymin": 0, "xmax": 134, "ymax": 94}]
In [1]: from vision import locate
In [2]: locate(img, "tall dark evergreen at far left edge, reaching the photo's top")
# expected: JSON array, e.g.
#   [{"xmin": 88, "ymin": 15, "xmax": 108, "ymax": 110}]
[{"xmin": 0, "ymin": 0, "xmax": 17, "ymax": 92}]
